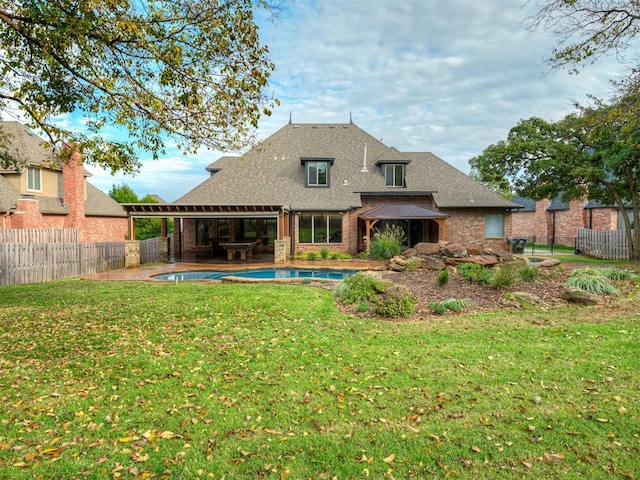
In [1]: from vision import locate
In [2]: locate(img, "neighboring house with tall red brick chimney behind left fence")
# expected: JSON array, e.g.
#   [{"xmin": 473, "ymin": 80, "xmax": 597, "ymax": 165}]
[{"xmin": 0, "ymin": 122, "xmax": 128, "ymax": 243}]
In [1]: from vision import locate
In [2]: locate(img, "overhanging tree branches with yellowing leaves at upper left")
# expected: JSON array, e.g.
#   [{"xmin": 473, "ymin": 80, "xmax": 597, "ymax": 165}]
[{"xmin": 0, "ymin": 0, "xmax": 277, "ymax": 172}]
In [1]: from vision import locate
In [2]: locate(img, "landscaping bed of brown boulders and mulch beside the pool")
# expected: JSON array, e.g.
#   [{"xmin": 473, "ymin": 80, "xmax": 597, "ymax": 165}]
[{"xmin": 339, "ymin": 243, "xmax": 633, "ymax": 320}]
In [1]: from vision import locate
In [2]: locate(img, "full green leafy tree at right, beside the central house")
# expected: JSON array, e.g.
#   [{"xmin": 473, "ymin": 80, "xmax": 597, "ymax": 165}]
[{"xmin": 469, "ymin": 76, "xmax": 640, "ymax": 260}]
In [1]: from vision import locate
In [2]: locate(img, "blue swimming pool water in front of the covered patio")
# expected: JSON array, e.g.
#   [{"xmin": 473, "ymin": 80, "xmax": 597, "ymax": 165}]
[{"xmin": 152, "ymin": 268, "xmax": 359, "ymax": 281}]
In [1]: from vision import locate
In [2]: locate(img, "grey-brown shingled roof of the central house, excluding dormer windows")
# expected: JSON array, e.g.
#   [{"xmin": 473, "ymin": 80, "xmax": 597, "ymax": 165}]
[{"xmin": 173, "ymin": 123, "xmax": 517, "ymax": 211}]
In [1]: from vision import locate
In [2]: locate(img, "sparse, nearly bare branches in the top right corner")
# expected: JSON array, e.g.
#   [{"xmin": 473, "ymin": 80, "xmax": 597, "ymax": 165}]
[{"xmin": 527, "ymin": 0, "xmax": 640, "ymax": 69}]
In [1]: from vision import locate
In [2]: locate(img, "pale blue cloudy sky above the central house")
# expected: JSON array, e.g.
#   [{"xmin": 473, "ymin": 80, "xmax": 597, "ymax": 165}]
[{"xmin": 67, "ymin": 0, "xmax": 629, "ymax": 202}]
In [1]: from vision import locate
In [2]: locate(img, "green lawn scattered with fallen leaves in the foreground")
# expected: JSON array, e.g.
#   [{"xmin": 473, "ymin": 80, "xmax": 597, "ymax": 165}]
[{"xmin": 0, "ymin": 280, "xmax": 640, "ymax": 479}]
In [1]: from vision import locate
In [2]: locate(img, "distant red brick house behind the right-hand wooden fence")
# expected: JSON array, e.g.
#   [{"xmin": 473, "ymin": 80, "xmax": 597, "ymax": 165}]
[{"xmin": 511, "ymin": 196, "xmax": 623, "ymax": 247}]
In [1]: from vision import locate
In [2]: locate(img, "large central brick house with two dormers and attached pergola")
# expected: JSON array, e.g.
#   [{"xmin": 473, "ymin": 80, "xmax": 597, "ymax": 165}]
[{"xmin": 142, "ymin": 122, "xmax": 517, "ymax": 261}]
